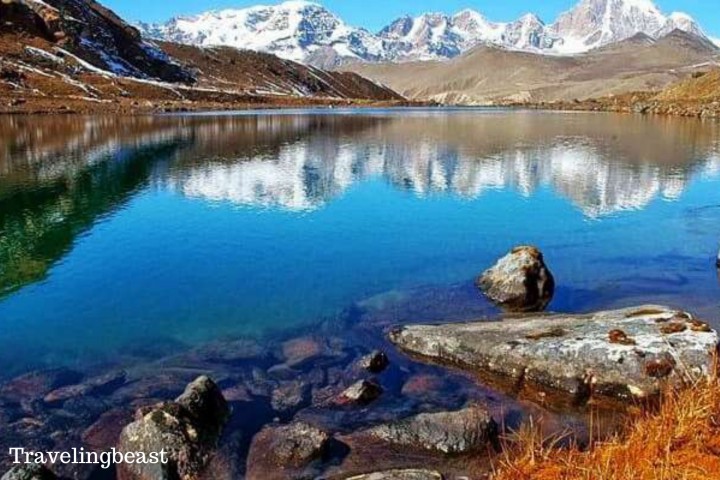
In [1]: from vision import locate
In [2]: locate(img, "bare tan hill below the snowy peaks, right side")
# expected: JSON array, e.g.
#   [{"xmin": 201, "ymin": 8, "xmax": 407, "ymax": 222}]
[{"xmin": 347, "ymin": 30, "xmax": 720, "ymax": 104}]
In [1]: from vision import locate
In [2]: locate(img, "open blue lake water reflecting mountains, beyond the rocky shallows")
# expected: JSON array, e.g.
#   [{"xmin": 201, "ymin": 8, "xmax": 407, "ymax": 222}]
[{"xmin": 0, "ymin": 110, "xmax": 720, "ymax": 376}]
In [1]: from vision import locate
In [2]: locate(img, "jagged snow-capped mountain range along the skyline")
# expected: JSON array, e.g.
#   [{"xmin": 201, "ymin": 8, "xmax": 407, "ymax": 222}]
[{"xmin": 139, "ymin": 0, "xmax": 707, "ymax": 66}]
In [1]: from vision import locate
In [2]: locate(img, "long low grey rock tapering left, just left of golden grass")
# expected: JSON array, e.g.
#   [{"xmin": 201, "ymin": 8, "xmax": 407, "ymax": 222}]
[{"xmin": 368, "ymin": 405, "xmax": 497, "ymax": 453}]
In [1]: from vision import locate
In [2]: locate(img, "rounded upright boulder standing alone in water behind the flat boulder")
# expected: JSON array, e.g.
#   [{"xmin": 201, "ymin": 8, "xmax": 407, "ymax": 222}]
[{"xmin": 476, "ymin": 247, "xmax": 555, "ymax": 312}]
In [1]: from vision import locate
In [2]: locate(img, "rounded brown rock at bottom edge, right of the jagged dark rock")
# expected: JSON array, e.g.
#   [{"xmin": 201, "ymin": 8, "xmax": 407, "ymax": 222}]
[{"xmin": 248, "ymin": 422, "xmax": 330, "ymax": 470}]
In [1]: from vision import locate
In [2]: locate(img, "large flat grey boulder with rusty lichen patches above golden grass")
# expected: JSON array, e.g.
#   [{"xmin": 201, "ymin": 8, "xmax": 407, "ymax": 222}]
[{"xmin": 390, "ymin": 305, "xmax": 718, "ymax": 399}]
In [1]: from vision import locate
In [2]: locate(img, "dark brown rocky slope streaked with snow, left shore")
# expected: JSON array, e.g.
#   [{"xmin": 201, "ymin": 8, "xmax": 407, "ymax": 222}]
[{"xmin": 0, "ymin": 0, "xmax": 403, "ymax": 111}]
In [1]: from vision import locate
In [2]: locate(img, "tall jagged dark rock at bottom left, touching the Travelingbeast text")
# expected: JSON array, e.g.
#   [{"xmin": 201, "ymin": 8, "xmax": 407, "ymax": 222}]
[{"xmin": 118, "ymin": 376, "xmax": 230, "ymax": 480}]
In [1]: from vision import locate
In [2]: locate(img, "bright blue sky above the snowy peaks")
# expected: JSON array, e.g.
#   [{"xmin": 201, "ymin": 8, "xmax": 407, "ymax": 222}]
[{"xmin": 108, "ymin": 0, "xmax": 720, "ymax": 36}]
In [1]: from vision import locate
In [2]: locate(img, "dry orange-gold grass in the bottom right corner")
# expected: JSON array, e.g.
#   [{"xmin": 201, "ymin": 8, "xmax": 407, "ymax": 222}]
[{"xmin": 493, "ymin": 378, "xmax": 720, "ymax": 480}]
